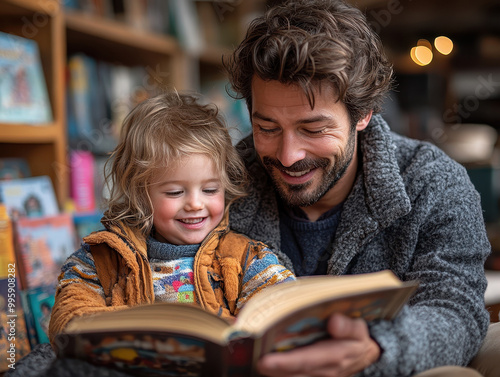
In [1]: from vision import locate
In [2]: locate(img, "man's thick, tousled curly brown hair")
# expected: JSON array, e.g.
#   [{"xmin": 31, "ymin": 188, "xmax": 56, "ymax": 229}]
[{"xmin": 224, "ymin": 0, "xmax": 392, "ymax": 124}]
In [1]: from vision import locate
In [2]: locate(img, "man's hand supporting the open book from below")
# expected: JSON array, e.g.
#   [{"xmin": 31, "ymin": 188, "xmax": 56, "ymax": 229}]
[{"xmin": 258, "ymin": 314, "xmax": 380, "ymax": 377}]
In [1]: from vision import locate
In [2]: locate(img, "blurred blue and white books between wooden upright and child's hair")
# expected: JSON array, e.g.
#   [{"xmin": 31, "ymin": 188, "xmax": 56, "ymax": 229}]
[{"xmin": 66, "ymin": 53, "xmax": 159, "ymax": 155}]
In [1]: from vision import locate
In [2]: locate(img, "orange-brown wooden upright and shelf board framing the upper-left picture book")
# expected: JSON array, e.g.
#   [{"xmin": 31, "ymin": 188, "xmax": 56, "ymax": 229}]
[{"xmin": 0, "ymin": 0, "xmax": 68, "ymax": 201}]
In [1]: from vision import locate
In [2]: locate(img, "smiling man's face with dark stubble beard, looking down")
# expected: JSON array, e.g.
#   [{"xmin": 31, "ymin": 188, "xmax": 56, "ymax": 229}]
[{"xmin": 251, "ymin": 77, "xmax": 367, "ymax": 207}]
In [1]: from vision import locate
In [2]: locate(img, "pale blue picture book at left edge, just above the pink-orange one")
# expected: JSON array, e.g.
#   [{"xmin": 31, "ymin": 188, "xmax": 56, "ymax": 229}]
[{"xmin": 0, "ymin": 175, "xmax": 59, "ymax": 220}]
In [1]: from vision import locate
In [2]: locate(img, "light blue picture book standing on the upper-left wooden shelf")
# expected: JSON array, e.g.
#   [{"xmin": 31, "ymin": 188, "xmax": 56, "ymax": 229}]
[{"xmin": 0, "ymin": 32, "xmax": 52, "ymax": 124}]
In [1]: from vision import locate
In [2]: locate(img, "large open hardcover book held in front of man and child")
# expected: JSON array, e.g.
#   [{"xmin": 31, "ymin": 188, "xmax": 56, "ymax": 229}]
[{"xmin": 55, "ymin": 271, "xmax": 418, "ymax": 376}]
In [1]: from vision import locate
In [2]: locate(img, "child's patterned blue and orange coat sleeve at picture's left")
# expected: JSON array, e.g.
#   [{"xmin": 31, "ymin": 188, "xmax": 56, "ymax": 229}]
[{"xmin": 49, "ymin": 244, "xmax": 127, "ymax": 347}]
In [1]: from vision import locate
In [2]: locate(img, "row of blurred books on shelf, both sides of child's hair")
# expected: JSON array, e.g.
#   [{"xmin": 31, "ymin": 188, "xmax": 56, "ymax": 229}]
[{"xmin": 66, "ymin": 53, "xmax": 251, "ymax": 151}]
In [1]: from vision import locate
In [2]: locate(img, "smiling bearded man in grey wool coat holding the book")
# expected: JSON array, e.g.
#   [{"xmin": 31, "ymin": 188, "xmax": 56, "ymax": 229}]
[{"xmin": 225, "ymin": 0, "xmax": 496, "ymax": 376}]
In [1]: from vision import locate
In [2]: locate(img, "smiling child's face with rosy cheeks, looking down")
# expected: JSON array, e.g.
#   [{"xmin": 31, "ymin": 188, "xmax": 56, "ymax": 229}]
[{"xmin": 149, "ymin": 154, "xmax": 224, "ymax": 245}]
